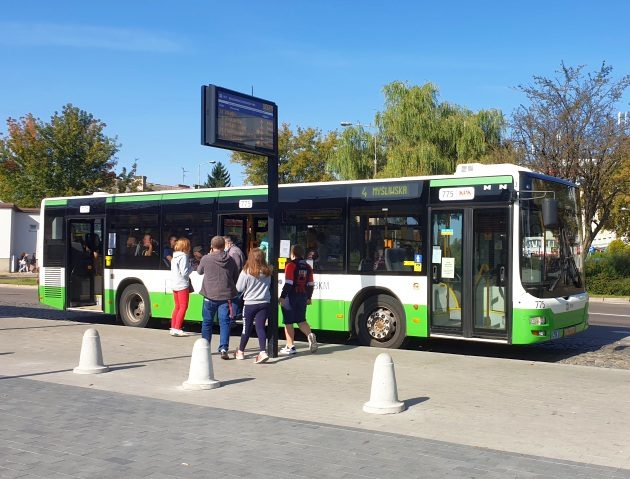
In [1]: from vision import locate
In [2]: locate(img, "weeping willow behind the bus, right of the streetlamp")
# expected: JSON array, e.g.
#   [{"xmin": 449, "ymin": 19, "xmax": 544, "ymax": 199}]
[{"xmin": 376, "ymin": 81, "xmax": 505, "ymax": 177}]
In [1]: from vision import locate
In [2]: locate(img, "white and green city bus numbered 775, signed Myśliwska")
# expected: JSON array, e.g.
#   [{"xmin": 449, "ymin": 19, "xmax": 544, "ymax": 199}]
[{"xmin": 38, "ymin": 164, "xmax": 588, "ymax": 348}]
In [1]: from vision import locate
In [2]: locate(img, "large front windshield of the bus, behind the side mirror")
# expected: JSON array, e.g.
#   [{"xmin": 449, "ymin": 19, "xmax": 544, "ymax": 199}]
[{"xmin": 520, "ymin": 174, "xmax": 585, "ymax": 298}]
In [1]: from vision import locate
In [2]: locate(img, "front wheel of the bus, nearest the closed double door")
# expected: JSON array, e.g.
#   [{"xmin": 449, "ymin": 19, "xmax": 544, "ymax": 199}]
[{"xmin": 355, "ymin": 294, "xmax": 406, "ymax": 349}]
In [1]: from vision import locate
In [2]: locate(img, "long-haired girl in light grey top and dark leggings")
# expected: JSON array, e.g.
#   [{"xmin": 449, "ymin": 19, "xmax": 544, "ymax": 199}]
[{"xmin": 234, "ymin": 248, "xmax": 271, "ymax": 364}]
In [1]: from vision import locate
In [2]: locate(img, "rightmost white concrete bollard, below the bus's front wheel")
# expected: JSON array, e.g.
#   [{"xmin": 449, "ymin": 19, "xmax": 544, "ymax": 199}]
[{"xmin": 363, "ymin": 353, "xmax": 405, "ymax": 414}]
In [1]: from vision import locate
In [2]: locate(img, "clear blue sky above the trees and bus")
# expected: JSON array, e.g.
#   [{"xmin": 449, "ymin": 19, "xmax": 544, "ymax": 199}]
[{"xmin": 0, "ymin": 0, "xmax": 630, "ymax": 185}]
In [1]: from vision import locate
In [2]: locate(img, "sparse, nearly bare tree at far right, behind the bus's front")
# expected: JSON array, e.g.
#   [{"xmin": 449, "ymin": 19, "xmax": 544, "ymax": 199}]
[{"xmin": 512, "ymin": 63, "xmax": 630, "ymax": 252}]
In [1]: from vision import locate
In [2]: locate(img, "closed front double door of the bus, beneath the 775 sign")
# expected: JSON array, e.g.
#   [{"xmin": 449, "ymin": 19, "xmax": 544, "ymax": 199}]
[{"xmin": 429, "ymin": 207, "xmax": 510, "ymax": 340}]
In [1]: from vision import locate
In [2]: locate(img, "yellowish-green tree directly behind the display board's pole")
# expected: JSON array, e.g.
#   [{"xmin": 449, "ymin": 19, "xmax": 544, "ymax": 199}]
[{"xmin": 232, "ymin": 123, "xmax": 337, "ymax": 185}]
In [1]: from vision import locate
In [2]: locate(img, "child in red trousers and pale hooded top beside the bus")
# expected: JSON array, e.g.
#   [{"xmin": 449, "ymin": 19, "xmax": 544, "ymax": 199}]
[{"xmin": 170, "ymin": 238, "xmax": 191, "ymax": 337}]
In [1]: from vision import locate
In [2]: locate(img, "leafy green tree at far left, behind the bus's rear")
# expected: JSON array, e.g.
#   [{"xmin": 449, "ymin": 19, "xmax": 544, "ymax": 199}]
[{"xmin": 0, "ymin": 104, "xmax": 123, "ymax": 207}]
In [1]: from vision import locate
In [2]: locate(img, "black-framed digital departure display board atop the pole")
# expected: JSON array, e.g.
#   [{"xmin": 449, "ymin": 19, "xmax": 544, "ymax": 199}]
[{"xmin": 201, "ymin": 85, "xmax": 278, "ymax": 156}]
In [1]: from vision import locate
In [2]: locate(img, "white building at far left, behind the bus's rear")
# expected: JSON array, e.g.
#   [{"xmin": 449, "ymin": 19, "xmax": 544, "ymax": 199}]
[{"xmin": 0, "ymin": 203, "xmax": 39, "ymax": 272}]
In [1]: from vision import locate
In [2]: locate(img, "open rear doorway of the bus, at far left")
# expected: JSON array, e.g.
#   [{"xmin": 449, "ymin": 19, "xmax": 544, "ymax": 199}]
[{"xmin": 66, "ymin": 218, "xmax": 103, "ymax": 311}]
